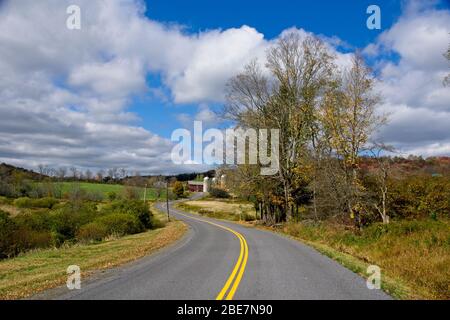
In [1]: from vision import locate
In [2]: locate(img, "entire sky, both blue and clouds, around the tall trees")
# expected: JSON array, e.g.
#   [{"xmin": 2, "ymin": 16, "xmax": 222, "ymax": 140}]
[{"xmin": 0, "ymin": 0, "xmax": 450, "ymax": 173}]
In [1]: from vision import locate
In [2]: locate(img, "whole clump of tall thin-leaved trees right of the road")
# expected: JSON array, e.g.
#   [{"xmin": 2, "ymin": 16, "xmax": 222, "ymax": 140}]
[{"xmin": 223, "ymin": 32, "xmax": 385, "ymax": 227}]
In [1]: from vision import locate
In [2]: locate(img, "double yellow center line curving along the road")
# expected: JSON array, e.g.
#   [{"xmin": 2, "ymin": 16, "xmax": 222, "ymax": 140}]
[{"xmin": 173, "ymin": 211, "xmax": 248, "ymax": 300}]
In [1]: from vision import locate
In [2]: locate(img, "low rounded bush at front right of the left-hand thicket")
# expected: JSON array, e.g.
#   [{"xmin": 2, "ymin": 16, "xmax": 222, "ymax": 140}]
[{"xmin": 95, "ymin": 213, "xmax": 144, "ymax": 236}]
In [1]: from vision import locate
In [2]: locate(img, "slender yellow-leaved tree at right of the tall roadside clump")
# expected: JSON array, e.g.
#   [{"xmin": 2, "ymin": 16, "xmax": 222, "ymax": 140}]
[{"xmin": 323, "ymin": 55, "xmax": 385, "ymax": 227}]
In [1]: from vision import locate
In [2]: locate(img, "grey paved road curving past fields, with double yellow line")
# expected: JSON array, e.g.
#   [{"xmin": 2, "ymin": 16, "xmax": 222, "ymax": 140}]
[{"xmin": 51, "ymin": 192, "xmax": 390, "ymax": 300}]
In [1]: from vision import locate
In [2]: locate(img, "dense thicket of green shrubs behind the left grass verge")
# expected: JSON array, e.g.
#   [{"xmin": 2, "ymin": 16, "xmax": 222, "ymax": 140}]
[{"xmin": 0, "ymin": 193, "xmax": 155, "ymax": 259}]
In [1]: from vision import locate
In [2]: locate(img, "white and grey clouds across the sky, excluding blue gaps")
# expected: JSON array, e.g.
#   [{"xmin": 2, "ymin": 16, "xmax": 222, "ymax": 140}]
[{"xmin": 0, "ymin": 0, "xmax": 450, "ymax": 173}]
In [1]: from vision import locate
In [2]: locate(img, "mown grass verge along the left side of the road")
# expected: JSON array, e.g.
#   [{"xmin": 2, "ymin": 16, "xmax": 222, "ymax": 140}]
[{"xmin": 0, "ymin": 208, "xmax": 187, "ymax": 299}]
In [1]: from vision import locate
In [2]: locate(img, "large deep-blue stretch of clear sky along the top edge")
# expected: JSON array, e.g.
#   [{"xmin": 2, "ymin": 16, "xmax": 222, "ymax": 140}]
[{"xmin": 146, "ymin": 0, "xmax": 401, "ymax": 47}]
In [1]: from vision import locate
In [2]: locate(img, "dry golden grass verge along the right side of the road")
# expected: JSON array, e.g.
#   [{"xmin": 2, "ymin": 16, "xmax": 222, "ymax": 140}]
[{"xmin": 180, "ymin": 200, "xmax": 450, "ymax": 299}]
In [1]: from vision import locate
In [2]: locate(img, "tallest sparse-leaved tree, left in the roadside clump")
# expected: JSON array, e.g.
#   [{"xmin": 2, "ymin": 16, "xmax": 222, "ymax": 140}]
[{"xmin": 224, "ymin": 32, "xmax": 335, "ymax": 220}]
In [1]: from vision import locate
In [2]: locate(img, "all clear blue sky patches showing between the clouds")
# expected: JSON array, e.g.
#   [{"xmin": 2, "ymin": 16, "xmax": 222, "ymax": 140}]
[{"xmin": 135, "ymin": 0, "xmax": 402, "ymax": 138}]
